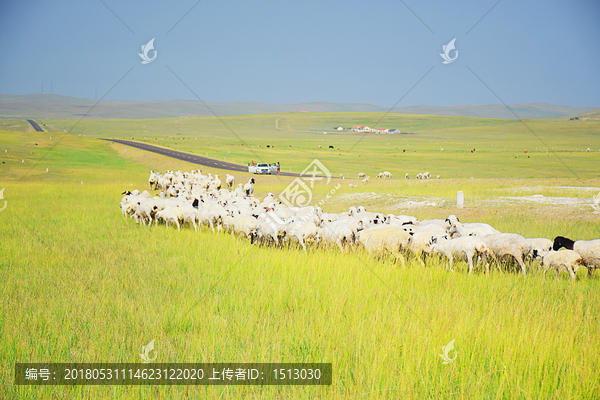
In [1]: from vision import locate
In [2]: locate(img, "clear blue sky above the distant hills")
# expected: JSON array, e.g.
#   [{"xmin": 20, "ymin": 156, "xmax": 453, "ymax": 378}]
[{"xmin": 0, "ymin": 0, "xmax": 600, "ymax": 107}]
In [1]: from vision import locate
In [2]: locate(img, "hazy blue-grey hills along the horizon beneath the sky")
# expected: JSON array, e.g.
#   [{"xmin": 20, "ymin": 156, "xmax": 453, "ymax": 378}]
[{"xmin": 0, "ymin": 94, "xmax": 600, "ymax": 119}]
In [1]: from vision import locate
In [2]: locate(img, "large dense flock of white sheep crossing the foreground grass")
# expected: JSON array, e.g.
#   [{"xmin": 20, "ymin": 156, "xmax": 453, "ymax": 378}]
[{"xmin": 119, "ymin": 171, "xmax": 600, "ymax": 279}]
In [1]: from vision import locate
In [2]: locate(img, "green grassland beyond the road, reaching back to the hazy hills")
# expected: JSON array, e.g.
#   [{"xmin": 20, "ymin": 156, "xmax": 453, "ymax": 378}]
[{"xmin": 37, "ymin": 113, "xmax": 600, "ymax": 179}]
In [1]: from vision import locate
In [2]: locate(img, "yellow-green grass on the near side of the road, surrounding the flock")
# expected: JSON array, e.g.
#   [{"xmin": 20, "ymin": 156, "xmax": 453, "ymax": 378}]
[{"xmin": 0, "ymin": 123, "xmax": 600, "ymax": 399}]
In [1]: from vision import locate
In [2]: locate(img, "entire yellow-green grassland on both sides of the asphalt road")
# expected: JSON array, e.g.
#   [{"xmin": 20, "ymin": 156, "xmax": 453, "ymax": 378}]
[{"xmin": 0, "ymin": 113, "xmax": 600, "ymax": 399}]
